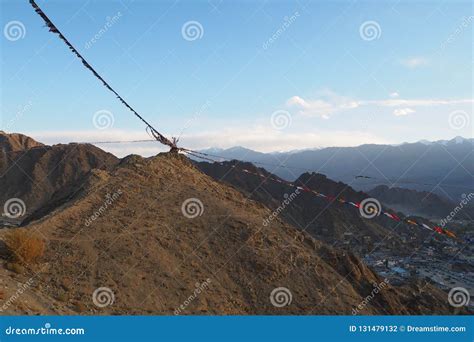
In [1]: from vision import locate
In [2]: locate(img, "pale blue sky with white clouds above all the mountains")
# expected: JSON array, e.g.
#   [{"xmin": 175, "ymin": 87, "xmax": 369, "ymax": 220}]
[{"xmin": 0, "ymin": 0, "xmax": 474, "ymax": 155}]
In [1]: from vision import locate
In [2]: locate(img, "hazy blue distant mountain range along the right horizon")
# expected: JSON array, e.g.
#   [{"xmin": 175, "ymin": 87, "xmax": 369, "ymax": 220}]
[{"xmin": 197, "ymin": 137, "xmax": 474, "ymax": 202}]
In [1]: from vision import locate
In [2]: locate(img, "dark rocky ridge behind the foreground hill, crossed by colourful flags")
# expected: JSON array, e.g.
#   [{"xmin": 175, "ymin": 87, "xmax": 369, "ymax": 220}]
[{"xmin": 197, "ymin": 161, "xmax": 414, "ymax": 255}]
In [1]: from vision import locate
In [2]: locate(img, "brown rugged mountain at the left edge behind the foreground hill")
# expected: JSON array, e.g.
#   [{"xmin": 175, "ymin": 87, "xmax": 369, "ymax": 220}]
[{"xmin": 0, "ymin": 134, "xmax": 118, "ymax": 223}]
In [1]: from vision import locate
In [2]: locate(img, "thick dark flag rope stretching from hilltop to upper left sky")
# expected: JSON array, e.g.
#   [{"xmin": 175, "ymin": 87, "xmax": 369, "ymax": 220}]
[{"xmin": 30, "ymin": 0, "xmax": 176, "ymax": 149}]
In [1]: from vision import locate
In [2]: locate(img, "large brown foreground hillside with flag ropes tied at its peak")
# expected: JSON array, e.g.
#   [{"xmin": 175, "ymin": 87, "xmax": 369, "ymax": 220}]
[{"xmin": 0, "ymin": 154, "xmax": 451, "ymax": 314}]
